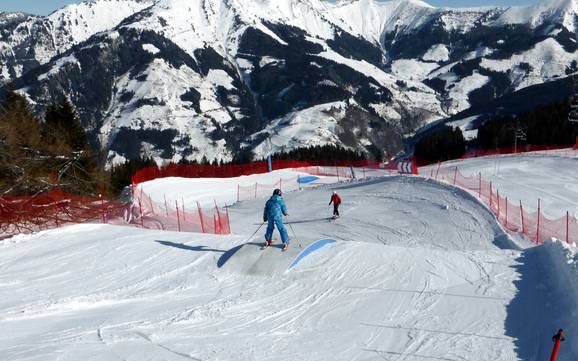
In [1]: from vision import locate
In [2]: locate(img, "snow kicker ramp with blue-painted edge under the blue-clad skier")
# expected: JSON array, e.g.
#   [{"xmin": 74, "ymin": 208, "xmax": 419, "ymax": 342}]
[{"xmin": 217, "ymin": 239, "xmax": 336, "ymax": 275}]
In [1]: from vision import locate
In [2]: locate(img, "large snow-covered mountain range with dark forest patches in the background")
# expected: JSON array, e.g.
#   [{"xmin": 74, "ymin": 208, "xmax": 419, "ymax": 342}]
[{"xmin": 0, "ymin": 0, "xmax": 578, "ymax": 162}]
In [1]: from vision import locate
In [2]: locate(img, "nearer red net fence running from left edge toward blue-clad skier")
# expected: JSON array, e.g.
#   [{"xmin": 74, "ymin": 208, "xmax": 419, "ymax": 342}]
[{"xmin": 0, "ymin": 189, "xmax": 231, "ymax": 239}]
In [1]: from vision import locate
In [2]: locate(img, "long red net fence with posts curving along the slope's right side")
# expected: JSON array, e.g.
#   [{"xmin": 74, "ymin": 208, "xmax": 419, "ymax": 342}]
[{"xmin": 422, "ymin": 166, "xmax": 578, "ymax": 244}]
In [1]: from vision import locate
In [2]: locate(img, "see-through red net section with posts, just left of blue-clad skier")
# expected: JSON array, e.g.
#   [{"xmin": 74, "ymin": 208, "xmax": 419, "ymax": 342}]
[{"xmin": 130, "ymin": 189, "xmax": 231, "ymax": 234}]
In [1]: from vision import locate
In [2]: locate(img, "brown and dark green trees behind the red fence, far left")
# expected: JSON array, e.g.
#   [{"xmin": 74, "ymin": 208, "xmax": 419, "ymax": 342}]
[{"xmin": 0, "ymin": 91, "xmax": 107, "ymax": 195}]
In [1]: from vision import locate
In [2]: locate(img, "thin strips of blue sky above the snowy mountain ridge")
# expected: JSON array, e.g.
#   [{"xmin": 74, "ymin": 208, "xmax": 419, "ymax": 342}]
[{"xmin": 0, "ymin": 0, "xmax": 538, "ymax": 15}]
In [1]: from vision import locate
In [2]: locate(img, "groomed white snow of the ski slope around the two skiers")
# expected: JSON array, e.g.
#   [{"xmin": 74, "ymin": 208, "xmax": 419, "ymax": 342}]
[{"xmin": 0, "ymin": 157, "xmax": 578, "ymax": 361}]
